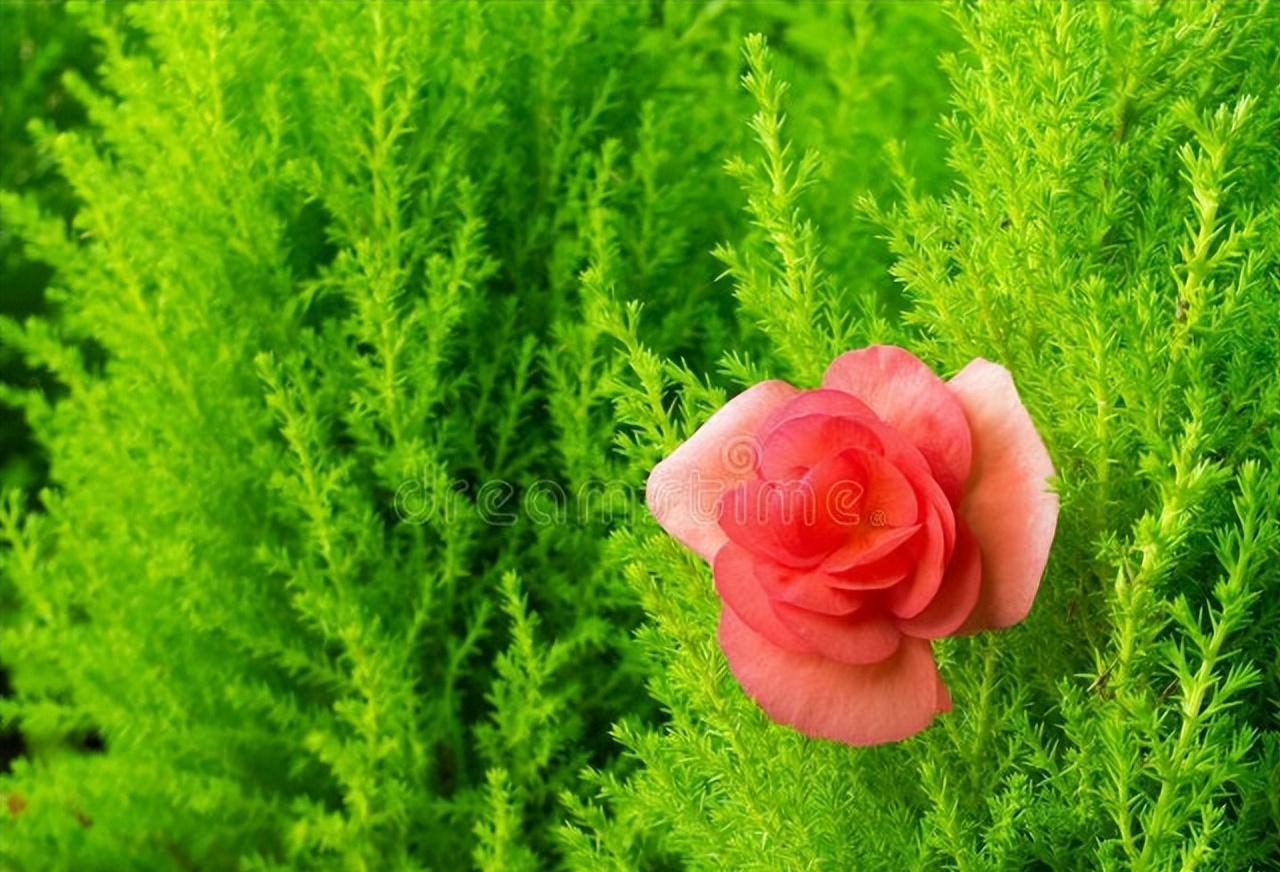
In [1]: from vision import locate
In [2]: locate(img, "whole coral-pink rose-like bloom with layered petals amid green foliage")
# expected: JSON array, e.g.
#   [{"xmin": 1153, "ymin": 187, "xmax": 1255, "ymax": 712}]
[{"xmin": 648, "ymin": 346, "xmax": 1057, "ymax": 745}]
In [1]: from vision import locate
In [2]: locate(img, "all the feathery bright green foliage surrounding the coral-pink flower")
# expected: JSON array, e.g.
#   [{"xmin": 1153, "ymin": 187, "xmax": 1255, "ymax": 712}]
[{"xmin": 0, "ymin": 0, "xmax": 1280, "ymax": 871}]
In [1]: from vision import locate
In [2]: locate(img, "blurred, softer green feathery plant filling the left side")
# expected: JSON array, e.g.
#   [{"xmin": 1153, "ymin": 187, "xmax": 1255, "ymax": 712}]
[{"xmin": 0, "ymin": 3, "xmax": 950, "ymax": 869}]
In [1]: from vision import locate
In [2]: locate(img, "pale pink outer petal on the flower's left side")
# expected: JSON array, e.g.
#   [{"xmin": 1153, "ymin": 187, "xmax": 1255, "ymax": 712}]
[{"xmin": 645, "ymin": 382, "xmax": 799, "ymax": 562}]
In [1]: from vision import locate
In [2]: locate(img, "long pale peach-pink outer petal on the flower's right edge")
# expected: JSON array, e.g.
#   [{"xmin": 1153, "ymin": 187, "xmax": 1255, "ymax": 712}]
[{"xmin": 948, "ymin": 357, "xmax": 1057, "ymax": 633}]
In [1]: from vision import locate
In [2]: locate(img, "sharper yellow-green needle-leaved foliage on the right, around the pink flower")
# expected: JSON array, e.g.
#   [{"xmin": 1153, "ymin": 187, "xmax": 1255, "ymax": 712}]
[{"xmin": 581, "ymin": 3, "xmax": 1280, "ymax": 869}]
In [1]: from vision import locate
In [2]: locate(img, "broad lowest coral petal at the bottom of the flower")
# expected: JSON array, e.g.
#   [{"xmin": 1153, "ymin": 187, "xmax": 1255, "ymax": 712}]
[{"xmin": 719, "ymin": 608, "xmax": 947, "ymax": 745}]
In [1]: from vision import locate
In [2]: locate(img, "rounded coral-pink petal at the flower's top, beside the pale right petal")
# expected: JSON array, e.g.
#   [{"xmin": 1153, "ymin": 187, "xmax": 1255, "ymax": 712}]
[{"xmin": 822, "ymin": 346, "xmax": 972, "ymax": 501}]
